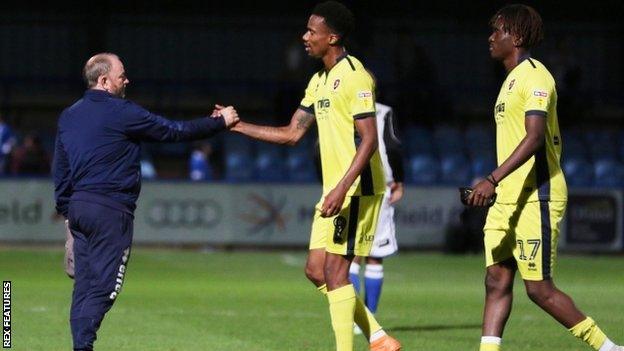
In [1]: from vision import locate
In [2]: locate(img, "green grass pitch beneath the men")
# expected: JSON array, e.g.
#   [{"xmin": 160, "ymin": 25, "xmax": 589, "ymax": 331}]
[{"xmin": 0, "ymin": 249, "xmax": 624, "ymax": 351}]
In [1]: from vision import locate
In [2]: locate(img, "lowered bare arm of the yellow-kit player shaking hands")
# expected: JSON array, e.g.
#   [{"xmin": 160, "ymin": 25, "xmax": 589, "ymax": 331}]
[{"xmin": 321, "ymin": 115, "xmax": 378, "ymax": 217}]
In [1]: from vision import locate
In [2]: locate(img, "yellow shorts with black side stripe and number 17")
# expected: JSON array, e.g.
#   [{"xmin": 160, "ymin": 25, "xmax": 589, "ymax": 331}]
[{"xmin": 483, "ymin": 201, "xmax": 566, "ymax": 281}]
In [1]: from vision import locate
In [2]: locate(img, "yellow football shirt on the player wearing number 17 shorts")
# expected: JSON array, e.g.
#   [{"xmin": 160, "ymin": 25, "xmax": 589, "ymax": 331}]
[{"xmin": 494, "ymin": 58, "xmax": 568, "ymax": 204}]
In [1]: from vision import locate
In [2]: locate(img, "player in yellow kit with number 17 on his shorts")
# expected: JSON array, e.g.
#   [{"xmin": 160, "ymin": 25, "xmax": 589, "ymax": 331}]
[{"xmin": 468, "ymin": 5, "xmax": 624, "ymax": 351}]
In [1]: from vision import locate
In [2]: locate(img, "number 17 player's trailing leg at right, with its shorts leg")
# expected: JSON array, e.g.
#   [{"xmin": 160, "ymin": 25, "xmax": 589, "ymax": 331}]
[{"xmin": 518, "ymin": 201, "xmax": 617, "ymax": 351}]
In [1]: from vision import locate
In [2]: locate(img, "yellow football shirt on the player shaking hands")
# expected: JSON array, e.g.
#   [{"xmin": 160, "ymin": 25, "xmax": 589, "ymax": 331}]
[{"xmin": 299, "ymin": 55, "xmax": 385, "ymax": 196}]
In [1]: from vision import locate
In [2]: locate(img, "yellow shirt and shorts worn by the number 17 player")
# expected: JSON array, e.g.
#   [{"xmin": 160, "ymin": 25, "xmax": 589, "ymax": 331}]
[{"xmin": 484, "ymin": 56, "xmax": 567, "ymax": 280}]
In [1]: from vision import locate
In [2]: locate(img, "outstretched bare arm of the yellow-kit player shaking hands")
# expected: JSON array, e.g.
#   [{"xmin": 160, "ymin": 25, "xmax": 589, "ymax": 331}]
[{"xmin": 231, "ymin": 109, "xmax": 314, "ymax": 145}]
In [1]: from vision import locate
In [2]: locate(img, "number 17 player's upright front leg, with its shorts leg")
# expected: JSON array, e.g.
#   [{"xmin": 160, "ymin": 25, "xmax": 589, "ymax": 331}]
[{"xmin": 480, "ymin": 204, "xmax": 516, "ymax": 351}]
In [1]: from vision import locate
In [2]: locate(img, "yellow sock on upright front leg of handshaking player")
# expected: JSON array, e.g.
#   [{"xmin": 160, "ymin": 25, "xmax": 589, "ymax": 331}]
[{"xmin": 327, "ymin": 284, "xmax": 356, "ymax": 351}]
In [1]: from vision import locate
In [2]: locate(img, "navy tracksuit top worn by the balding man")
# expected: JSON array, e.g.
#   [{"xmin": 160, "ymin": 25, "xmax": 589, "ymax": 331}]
[{"xmin": 53, "ymin": 89, "xmax": 225, "ymax": 218}]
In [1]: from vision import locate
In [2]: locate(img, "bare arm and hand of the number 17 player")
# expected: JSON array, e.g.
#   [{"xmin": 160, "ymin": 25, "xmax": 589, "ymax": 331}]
[{"xmin": 468, "ymin": 115, "xmax": 546, "ymax": 206}]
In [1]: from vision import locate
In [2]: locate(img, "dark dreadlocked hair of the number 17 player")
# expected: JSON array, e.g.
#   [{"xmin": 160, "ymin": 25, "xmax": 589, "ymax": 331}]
[{"xmin": 490, "ymin": 4, "xmax": 544, "ymax": 49}]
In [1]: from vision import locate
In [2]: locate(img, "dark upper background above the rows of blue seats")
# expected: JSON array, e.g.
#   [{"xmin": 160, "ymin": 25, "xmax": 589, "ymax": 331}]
[{"xmin": 0, "ymin": 0, "xmax": 624, "ymax": 179}]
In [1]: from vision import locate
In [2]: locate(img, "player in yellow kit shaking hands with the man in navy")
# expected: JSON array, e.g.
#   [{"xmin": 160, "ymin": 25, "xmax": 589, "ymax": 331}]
[{"xmin": 232, "ymin": 1, "xmax": 401, "ymax": 351}]
